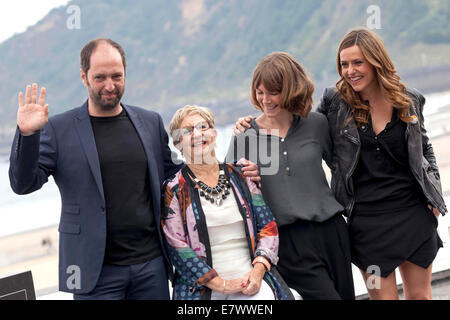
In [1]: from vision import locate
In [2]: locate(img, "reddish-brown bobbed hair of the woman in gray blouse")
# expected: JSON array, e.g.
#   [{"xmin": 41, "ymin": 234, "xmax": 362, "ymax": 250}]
[{"xmin": 251, "ymin": 52, "xmax": 314, "ymax": 118}]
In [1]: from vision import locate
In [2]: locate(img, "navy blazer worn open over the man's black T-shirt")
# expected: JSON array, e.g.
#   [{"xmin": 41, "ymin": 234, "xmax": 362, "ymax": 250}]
[{"xmin": 9, "ymin": 101, "xmax": 182, "ymax": 294}]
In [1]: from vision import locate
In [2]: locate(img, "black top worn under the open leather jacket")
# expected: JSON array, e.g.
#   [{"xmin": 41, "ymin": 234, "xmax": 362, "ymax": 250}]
[{"xmin": 353, "ymin": 108, "xmax": 422, "ymax": 211}]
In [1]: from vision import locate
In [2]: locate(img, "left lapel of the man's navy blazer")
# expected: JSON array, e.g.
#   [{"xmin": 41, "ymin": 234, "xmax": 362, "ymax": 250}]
[{"xmin": 75, "ymin": 101, "xmax": 105, "ymax": 199}]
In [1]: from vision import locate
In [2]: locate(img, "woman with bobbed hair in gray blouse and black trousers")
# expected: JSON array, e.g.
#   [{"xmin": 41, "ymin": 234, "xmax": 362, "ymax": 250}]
[{"xmin": 226, "ymin": 52, "xmax": 355, "ymax": 300}]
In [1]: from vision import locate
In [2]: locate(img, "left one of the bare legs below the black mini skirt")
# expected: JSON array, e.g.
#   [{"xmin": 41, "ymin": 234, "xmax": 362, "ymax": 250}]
[{"xmin": 360, "ymin": 269, "xmax": 398, "ymax": 300}]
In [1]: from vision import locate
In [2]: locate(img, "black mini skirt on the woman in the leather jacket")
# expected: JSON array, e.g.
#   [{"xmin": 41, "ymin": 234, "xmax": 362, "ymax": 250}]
[{"xmin": 349, "ymin": 204, "xmax": 443, "ymax": 278}]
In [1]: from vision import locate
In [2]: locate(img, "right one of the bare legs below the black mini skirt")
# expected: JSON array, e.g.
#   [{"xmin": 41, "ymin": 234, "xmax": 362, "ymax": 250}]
[{"xmin": 399, "ymin": 261, "xmax": 432, "ymax": 300}]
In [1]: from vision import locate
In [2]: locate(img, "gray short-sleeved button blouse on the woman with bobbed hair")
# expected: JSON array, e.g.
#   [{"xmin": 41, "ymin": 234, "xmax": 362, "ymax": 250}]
[{"xmin": 226, "ymin": 112, "xmax": 344, "ymax": 227}]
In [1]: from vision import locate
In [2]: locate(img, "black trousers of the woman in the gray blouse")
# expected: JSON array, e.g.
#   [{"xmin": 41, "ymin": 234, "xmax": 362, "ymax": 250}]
[{"xmin": 278, "ymin": 214, "xmax": 355, "ymax": 300}]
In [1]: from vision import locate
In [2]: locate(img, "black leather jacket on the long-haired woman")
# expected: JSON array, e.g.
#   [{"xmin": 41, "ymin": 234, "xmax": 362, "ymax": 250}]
[{"xmin": 317, "ymin": 88, "xmax": 447, "ymax": 217}]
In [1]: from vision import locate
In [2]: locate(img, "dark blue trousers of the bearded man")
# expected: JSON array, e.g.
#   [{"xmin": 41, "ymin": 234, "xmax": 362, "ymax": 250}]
[{"xmin": 74, "ymin": 256, "xmax": 170, "ymax": 300}]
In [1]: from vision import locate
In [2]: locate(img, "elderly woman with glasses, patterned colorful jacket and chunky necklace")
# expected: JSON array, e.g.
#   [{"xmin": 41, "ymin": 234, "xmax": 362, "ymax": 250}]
[{"xmin": 161, "ymin": 106, "xmax": 293, "ymax": 300}]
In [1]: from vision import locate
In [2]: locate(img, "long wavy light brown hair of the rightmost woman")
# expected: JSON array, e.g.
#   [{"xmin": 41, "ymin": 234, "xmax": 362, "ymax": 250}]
[{"xmin": 336, "ymin": 28, "xmax": 413, "ymax": 126}]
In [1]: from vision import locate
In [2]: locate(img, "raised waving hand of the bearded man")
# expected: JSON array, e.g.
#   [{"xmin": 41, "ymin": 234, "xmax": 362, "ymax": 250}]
[{"xmin": 17, "ymin": 83, "xmax": 48, "ymax": 136}]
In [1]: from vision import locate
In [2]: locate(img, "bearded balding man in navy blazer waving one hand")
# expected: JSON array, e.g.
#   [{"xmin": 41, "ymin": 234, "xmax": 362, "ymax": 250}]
[{"xmin": 9, "ymin": 39, "xmax": 180, "ymax": 299}]
